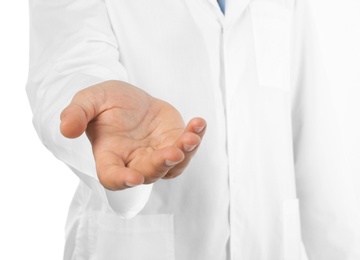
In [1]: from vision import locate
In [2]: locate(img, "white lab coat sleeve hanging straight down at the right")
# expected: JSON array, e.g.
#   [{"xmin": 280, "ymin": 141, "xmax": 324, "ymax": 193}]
[{"xmin": 291, "ymin": 0, "xmax": 360, "ymax": 260}]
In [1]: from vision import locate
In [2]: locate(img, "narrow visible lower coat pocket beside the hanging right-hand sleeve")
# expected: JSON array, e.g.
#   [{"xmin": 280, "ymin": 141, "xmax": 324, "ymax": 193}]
[{"xmin": 282, "ymin": 199, "xmax": 302, "ymax": 260}]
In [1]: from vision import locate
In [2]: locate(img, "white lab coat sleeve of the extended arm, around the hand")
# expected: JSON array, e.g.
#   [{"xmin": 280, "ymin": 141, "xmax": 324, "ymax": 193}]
[{"xmin": 26, "ymin": 0, "xmax": 152, "ymax": 218}]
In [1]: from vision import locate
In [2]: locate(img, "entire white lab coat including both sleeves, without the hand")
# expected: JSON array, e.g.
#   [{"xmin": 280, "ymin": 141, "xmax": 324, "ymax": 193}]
[{"xmin": 27, "ymin": 0, "xmax": 360, "ymax": 260}]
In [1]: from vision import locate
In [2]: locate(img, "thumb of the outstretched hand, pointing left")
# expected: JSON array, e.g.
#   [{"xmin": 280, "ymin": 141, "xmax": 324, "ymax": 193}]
[{"xmin": 60, "ymin": 88, "xmax": 101, "ymax": 138}]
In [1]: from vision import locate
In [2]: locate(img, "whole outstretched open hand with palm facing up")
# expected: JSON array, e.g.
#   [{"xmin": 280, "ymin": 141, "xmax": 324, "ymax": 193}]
[{"xmin": 60, "ymin": 81, "xmax": 206, "ymax": 190}]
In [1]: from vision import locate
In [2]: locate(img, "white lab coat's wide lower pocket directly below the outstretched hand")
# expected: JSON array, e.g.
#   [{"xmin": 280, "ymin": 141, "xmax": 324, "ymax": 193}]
[{"xmin": 92, "ymin": 212, "xmax": 175, "ymax": 260}]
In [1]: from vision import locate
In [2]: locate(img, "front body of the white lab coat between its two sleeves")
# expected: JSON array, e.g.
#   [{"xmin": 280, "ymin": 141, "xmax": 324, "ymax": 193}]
[{"xmin": 67, "ymin": 0, "xmax": 300, "ymax": 260}]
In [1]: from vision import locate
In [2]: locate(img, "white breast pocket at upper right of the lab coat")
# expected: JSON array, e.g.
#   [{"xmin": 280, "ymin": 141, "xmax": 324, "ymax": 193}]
[{"xmin": 250, "ymin": 0, "xmax": 292, "ymax": 91}]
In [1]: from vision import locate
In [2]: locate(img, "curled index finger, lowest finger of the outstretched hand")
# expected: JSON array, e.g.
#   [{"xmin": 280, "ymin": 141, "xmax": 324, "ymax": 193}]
[{"xmin": 95, "ymin": 151, "xmax": 144, "ymax": 190}]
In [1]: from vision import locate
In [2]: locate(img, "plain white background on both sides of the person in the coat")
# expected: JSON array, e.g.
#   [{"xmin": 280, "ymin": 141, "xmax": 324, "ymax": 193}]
[{"xmin": 0, "ymin": 0, "xmax": 360, "ymax": 260}]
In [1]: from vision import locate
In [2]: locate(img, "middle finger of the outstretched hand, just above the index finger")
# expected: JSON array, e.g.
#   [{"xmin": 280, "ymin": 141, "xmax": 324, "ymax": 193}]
[{"xmin": 127, "ymin": 146, "xmax": 185, "ymax": 184}]
